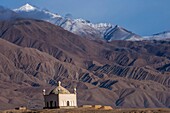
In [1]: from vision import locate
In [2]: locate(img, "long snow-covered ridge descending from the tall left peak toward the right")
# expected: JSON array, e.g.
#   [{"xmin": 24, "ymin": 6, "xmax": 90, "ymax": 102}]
[{"xmin": 14, "ymin": 4, "xmax": 141, "ymax": 41}]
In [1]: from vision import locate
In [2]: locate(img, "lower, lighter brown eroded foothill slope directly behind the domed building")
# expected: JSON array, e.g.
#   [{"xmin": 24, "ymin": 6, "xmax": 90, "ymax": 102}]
[{"xmin": 0, "ymin": 39, "xmax": 170, "ymax": 109}]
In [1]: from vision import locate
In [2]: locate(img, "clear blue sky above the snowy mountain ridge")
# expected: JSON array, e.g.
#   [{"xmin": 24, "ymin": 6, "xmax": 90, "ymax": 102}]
[{"xmin": 0, "ymin": 0, "xmax": 170, "ymax": 35}]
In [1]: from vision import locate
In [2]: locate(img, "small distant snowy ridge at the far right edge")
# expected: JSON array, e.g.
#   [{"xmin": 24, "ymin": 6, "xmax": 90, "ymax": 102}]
[{"xmin": 144, "ymin": 31, "xmax": 170, "ymax": 40}]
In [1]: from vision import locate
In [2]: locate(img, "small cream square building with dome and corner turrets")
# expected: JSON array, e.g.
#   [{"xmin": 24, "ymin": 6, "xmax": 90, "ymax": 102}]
[{"xmin": 43, "ymin": 81, "xmax": 77, "ymax": 109}]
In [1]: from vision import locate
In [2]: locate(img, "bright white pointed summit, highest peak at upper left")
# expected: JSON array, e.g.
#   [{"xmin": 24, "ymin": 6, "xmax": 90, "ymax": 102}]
[{"xmin": 14, "ymin": 3, "xmax": 37, "ymax": 12}]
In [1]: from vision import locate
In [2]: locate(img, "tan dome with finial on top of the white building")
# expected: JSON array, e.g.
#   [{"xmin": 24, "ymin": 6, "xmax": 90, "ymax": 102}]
[{"xmin": 50, "ymin": 81, "xmax": 70, "ymax": 94}]
